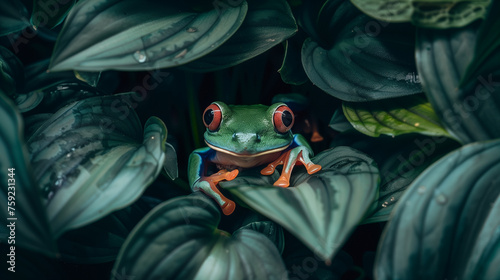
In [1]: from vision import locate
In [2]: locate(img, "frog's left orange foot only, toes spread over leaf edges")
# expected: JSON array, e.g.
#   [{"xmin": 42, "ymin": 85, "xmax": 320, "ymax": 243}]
[{"xmin": 202, "ymin": 169, "xmax": 239, "ymax": 216}]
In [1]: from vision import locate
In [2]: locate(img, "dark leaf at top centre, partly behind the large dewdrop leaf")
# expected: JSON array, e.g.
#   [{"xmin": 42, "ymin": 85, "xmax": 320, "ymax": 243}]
[{"xmin": 183, "ymin": 0, "xmax": 297, "ymax": 72}]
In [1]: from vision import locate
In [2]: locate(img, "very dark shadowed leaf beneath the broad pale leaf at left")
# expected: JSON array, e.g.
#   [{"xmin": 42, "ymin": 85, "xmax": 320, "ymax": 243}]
[{"xmin": 57, "ymin": 198, "xmax": 156, "ymax": 264}]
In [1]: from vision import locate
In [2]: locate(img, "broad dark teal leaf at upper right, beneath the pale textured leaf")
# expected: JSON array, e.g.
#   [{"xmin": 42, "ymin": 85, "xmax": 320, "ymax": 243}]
[{"xmin": 302, "ymin": 0, "xmax": 422, "ymax": 102}]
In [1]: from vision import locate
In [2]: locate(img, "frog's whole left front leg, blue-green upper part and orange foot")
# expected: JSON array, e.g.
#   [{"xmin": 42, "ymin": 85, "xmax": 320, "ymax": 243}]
[{"xmin": 188, "ymin": 148, "xmax": 239, "ymax": 215}]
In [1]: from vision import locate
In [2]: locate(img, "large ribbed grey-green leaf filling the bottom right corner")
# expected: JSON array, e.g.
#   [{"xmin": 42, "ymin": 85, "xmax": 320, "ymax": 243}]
[{"xmin": 375, "ymin": 140, "xmax": 500, "ymax": 279}]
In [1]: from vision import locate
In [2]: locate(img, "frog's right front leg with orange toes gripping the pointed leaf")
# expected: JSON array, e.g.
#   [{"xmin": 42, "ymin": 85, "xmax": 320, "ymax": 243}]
[{"xmin": 260, "ymin": 136, "xmax": 321, "ymax": 188}]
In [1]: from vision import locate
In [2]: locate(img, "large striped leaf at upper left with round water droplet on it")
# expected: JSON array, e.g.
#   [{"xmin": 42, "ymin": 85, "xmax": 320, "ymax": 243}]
[{"xmin": 50, "ymin": 0, "xmax": 247, "ymax": 71}]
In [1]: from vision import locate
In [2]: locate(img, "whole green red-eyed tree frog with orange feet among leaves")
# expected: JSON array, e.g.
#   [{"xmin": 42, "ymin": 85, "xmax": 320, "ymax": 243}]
[{"xmin": 188, "ymin": 102, "xmax": 321, "ymax": 215}]
